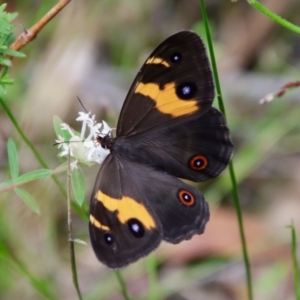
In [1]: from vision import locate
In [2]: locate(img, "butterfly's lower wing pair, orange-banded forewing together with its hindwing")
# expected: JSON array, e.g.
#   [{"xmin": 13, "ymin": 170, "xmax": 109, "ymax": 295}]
[{"xmin": 89, "ymin": 154, "xmax": 209, "ymax": 268}]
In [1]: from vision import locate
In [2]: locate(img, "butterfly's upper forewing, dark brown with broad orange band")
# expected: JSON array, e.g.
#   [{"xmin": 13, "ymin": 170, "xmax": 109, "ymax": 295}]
[{"xmin": 117, "ymin": 31, "xmax": 214, "ymax": 136}]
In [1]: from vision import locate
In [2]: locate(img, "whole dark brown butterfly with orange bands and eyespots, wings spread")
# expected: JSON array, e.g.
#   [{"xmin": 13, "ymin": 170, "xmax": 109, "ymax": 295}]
[{"xmin": 89, "ymin": 31, "xmax": 233, "ymax": 269}]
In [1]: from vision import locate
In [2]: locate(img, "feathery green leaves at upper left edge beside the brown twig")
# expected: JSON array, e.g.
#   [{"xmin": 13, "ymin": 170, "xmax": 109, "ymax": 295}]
[{"xmin": 0, "ymin": 3, "xmax": 25, "ymax": 91}]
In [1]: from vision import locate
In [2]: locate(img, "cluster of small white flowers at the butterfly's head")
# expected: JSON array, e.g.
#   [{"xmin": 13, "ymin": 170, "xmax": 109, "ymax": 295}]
[{"xmin": 56, "ymin": 112, "xmax": 112, "ymax": 169}]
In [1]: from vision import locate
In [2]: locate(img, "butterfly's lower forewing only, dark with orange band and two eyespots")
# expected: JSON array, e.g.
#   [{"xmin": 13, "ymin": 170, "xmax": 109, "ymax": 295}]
[{"xmin": 89, "ymin": 154, "xmax": 162, "ymax": 268}]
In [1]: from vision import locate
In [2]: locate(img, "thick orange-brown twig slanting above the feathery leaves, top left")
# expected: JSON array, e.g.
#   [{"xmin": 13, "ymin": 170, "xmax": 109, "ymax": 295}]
[{"xmin": 9, "ymin": 0, "xmax": 71, "ymax": 50}]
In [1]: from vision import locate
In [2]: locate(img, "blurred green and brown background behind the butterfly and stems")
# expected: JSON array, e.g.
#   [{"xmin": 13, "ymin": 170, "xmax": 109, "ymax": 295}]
[{"xmin": 0, "ymin": 0, "xmax": 300, "ymax": 300}]
